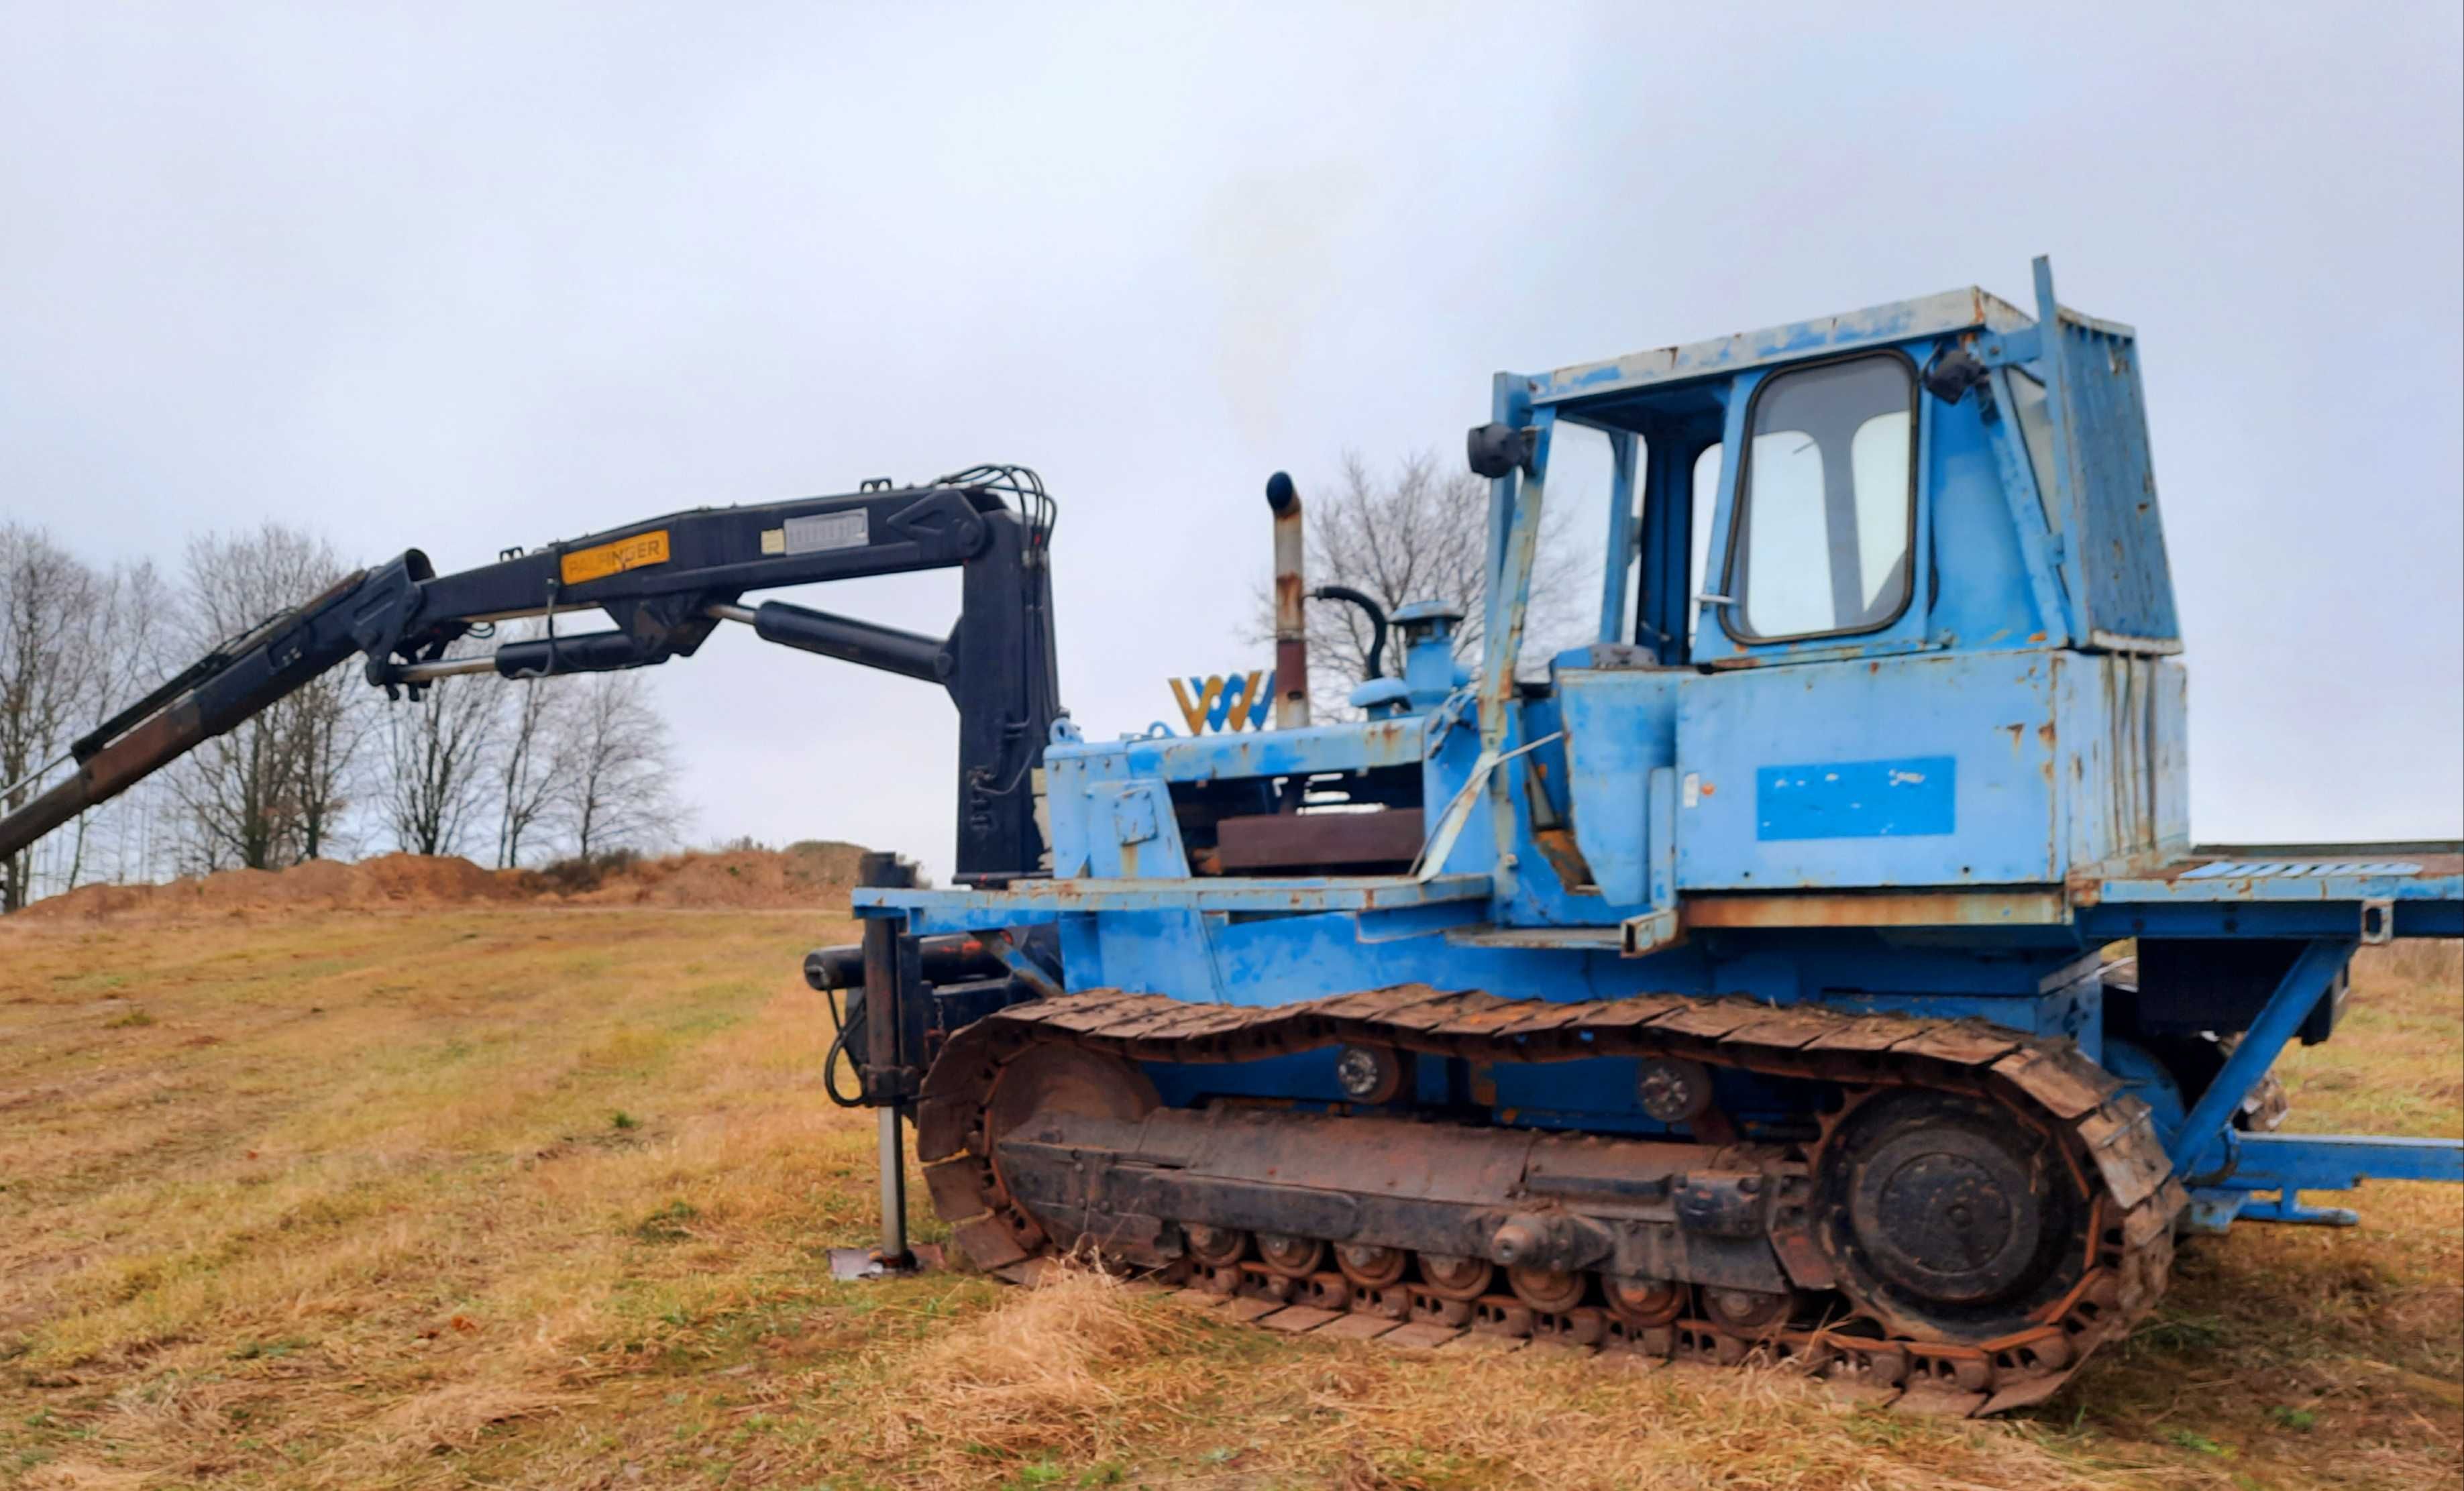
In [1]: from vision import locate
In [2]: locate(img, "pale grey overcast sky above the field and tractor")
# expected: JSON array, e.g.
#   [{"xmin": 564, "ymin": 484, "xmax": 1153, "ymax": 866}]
[{"xmin": 0, "ymin": 0, "xmax": 2464, "ymax": 873}]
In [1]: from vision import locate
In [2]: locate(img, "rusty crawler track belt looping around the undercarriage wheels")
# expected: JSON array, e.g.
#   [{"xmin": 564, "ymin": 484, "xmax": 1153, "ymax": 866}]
[{"xmin": 916, "ymin": 983, "xmax": 2186, "ymax": 1415}]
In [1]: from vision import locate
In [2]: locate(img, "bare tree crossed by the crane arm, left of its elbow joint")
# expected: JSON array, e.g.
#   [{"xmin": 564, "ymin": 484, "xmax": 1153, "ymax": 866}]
[{"xmin": 172, "ymin": 522, "xmax": 370, "ymax": 870}]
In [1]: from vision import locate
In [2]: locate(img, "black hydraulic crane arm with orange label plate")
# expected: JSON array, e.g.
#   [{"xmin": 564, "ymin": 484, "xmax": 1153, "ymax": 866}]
[{"xmin": 0, "ymin": 465, "xmax": 1059, "ymax": 882}]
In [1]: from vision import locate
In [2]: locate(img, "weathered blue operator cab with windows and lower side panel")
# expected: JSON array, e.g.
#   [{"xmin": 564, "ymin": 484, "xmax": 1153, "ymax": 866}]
[{"xmin": 1471, "ymin": 261, "xmax": 2188, "ymax": 924}]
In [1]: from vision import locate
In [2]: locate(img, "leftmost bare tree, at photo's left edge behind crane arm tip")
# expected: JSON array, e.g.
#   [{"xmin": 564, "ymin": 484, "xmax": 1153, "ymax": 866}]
[{"xmin": 0, "ymin": 522, "xmax": 111, "ymax": 912}]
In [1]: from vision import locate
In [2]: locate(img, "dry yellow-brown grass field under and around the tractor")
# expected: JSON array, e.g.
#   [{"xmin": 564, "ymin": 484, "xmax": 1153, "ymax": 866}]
[{"xmin": 0, "ymin": 887, "xmax": 2464, "ymax": 1491}]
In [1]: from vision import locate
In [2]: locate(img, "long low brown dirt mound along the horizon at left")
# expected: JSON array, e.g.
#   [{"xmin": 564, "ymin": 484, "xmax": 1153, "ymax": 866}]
[{"xmin": 7, "ymin": 840, "xmax": 865, "ymax": 922}]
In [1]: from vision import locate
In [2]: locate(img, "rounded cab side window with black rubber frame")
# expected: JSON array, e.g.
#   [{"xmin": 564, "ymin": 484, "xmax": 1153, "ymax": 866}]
[{"xmin": 1722, "ymin": 352, "xmax": 1917, "ymax": 641}]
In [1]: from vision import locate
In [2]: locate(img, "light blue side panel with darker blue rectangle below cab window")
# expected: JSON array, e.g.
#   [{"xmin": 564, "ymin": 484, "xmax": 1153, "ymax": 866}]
[{"xmin": 1678, "ymin": 653, "xmax": 2065, "ymax": 889}]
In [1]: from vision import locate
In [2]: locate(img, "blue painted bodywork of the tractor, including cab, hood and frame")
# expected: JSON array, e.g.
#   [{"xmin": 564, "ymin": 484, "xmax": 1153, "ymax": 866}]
[{"xmin": 855, "ymin": 266, "xmax": 2464, "ymax": 1225}]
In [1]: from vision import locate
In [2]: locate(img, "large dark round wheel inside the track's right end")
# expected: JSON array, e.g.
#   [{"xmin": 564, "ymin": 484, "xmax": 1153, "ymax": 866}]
[{"xmin": 1819, "ymin": 1092, "xmax": 2087, "ymax": 1341}]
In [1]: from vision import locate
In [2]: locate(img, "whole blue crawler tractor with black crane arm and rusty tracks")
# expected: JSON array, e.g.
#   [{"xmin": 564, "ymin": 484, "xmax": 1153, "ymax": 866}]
[{"xmin": 0, "ymin": 261, "xmax": 2464, "ymax": 1415}]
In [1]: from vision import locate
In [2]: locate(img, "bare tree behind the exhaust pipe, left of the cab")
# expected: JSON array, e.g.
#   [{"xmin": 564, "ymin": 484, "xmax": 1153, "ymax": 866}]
[{"xmin": 1249, "ymin": 451, "xmax": 1597, "ymax": 712}]
